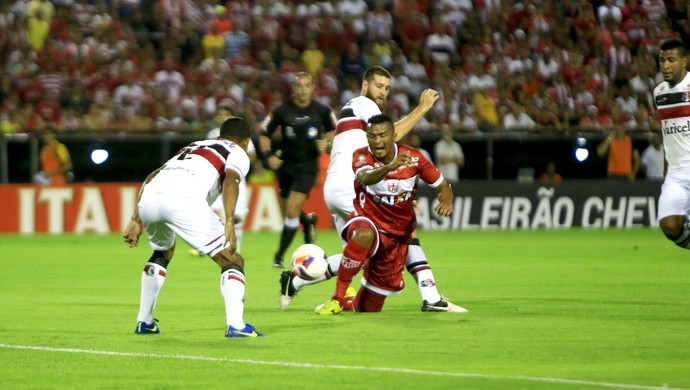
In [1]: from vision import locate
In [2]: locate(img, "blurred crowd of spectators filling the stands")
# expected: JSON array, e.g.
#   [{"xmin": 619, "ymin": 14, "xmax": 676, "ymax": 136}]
[{"xmin": 0, "ymin": 0, "xmax": 690, "ymax": 138}]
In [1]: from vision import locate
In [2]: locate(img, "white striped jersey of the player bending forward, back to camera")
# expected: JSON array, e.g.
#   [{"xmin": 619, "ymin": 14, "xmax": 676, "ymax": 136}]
[{"xmin": 147, "ymin": 139, "xmax": 249, "ymax": 205}]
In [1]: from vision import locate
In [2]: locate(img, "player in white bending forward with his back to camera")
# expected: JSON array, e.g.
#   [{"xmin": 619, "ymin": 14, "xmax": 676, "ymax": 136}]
[{"xmin": 123, "ymin": 118, "xmax": 263, "ymax": 337}]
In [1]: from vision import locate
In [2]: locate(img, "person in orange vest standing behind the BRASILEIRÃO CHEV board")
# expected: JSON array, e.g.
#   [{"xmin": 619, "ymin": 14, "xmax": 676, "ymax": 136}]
[{"xmin": 597, "ymin": 125, "xmax": 640, "ymax": 181}]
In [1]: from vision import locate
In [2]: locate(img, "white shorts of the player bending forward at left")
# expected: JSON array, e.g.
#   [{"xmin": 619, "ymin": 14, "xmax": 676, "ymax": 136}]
[{"xmin": 138, "ymin": 183, "xmax": 225, "ymax": 256}]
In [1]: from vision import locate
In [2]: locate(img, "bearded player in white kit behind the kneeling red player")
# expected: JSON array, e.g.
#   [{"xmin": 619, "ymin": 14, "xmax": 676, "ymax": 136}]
[{"xmin": 280, "ymin": 66, "xmax": 465, "ymax": 312}]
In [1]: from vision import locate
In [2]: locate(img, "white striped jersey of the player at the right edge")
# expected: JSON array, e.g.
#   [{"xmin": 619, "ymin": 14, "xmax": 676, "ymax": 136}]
[{"xmin": 654, "ymin": 72, "xmax": 690, "ymax": 172}]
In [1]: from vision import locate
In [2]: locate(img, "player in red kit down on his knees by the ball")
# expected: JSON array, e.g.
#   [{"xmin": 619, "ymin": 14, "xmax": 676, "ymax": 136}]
[{"xmin": 316, "ymin": 114, "xmax": 466, "ymax": 315}]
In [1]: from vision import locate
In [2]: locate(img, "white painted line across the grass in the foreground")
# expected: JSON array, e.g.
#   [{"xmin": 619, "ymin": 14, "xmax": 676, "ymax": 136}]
[{"xmin": 0, "ymin": 344, "xmax": 684, "ymax": 390}]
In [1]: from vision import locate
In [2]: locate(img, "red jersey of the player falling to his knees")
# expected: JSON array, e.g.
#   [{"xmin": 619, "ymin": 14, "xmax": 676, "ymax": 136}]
[{"xmin": 352, "ymin": 144, "xmax": 443, "ymax": 237}]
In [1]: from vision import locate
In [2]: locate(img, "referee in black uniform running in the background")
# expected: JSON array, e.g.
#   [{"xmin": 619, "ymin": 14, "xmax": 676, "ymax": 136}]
[{"xmin": 261, "ymin": 72, "xmax": 336, "ymax": 268}]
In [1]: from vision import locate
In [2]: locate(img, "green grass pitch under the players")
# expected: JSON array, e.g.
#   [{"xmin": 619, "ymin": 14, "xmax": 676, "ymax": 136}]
[{"xmin": 0, "ymin": 229, "xmax": 690, "ymax": 389}]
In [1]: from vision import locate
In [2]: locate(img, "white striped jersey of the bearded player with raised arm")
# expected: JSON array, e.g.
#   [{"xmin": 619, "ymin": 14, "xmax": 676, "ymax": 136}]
[{"xmin": 326, "ymin": 96, "xmax": 381, "ymax": 188}]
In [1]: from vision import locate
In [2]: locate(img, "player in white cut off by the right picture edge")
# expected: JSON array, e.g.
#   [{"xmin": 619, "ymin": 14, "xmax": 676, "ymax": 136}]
[{"xmin": 654, "ymin": 39, "xmax": 690, "ymax": 249}]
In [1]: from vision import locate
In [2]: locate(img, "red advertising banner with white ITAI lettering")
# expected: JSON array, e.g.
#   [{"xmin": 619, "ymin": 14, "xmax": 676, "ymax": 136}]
[{"xmin": 0, "ymin": 183, "xmax": 332, "ymax": 234}]
